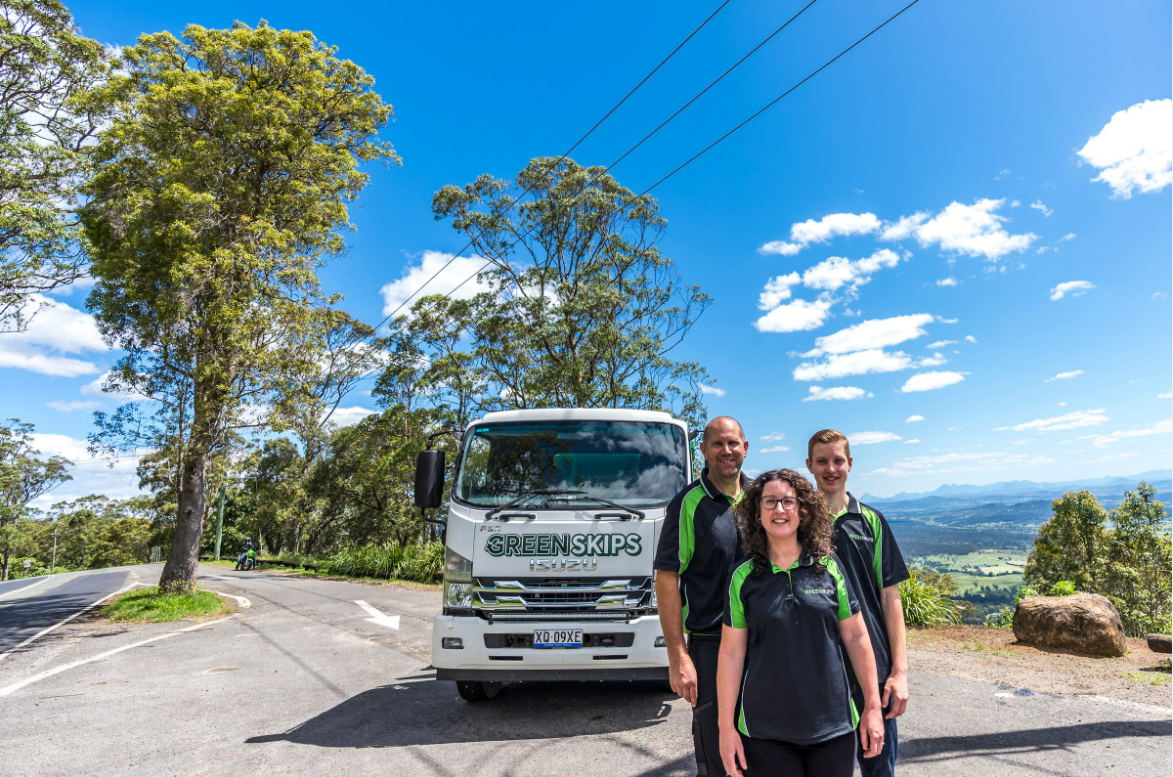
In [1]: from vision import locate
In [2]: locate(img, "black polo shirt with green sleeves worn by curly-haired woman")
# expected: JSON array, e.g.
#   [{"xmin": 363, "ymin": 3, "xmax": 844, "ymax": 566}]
[{"xmin": 725, "ymin": 556, "xmax": 860, "ymax": 744}]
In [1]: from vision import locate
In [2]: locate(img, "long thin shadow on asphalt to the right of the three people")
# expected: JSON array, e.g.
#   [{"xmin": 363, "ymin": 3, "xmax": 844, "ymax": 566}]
[{"xmin": 900, "ymin": 718, "xmax": 1169, "ymax": 763}]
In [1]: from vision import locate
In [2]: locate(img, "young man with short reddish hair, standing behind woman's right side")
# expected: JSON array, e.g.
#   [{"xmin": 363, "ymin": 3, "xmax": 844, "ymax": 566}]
[{"xmin": 807, "ymin": 428, "xmax": 908, "ymax": 777}]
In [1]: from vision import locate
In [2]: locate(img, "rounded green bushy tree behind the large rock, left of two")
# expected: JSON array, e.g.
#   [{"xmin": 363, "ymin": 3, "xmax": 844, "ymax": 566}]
[{"xmin": 1023, "ymin": 491, "xmax": 1107, "ymax": 592}]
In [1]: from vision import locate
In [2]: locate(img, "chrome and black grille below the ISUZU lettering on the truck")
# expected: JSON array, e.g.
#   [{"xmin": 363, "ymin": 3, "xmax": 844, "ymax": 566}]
[{"xmin": 473, "ymin": 576, "xmax": 652, "ymax": 620}]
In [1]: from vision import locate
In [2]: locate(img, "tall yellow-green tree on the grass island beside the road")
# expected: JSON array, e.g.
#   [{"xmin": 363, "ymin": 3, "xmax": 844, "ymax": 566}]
[{"xmin": 83, "ymin": 22, "xmax": 398, "ymax": 592}]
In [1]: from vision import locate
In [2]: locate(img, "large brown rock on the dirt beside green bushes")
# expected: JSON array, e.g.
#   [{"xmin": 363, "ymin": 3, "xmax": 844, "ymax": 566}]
[{"xmin": 1015, "ymin": 594, "xmax": 1125, "ymax": 656}]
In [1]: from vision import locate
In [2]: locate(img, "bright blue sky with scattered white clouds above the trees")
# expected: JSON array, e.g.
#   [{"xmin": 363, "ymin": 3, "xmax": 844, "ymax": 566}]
[{"xmin": 0, "ymin": 0, "xmax": 1173, "ymax": 501}]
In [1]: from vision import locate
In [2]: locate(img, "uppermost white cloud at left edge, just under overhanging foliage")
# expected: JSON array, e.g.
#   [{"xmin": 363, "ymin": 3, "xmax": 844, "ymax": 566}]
[{"xmin": 0, "ymin": 295, "xmax": 108, "ymax": 378}]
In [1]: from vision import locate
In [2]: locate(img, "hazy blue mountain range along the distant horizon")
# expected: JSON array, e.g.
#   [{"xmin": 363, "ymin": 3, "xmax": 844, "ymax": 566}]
[{"xmin": 860, "ymin": 469, "xmax": 1173, "ymax": 507}]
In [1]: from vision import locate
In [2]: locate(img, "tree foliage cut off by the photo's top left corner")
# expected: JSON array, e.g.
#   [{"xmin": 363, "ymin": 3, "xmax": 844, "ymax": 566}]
[{"xmin": 0, "ymin": 0, "xmax": 107, "ymax": 332}]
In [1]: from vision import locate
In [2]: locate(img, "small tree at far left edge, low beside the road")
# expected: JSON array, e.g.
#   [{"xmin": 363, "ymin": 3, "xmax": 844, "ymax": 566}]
[{"xmin": 0, "ymin": 419, "xmax": 72, "ymax": 580}]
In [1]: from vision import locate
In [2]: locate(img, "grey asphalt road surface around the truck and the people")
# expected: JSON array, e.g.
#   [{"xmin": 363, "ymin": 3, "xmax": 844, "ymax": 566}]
[{"xmin": 0, "ymin": 566, "xmax": 1171, "ymax": 777}]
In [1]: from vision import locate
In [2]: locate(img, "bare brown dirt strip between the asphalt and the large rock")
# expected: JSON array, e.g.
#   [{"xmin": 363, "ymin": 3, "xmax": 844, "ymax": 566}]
[{"xmin": 908, "ymin": 626, "xmax": 1173, "ymax": 708}]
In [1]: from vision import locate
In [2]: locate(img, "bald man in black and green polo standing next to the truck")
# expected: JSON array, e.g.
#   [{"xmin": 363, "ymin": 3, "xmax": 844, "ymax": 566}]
[{"xmin": 653, "ymin": 417, "xmax": 750, "ymax": 777}]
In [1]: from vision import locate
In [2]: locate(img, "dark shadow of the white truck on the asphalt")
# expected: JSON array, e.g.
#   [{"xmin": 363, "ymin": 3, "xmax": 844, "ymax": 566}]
[{"xmin": 245, "ymin": 675, "xmax": 676, "ymax": 751}]
